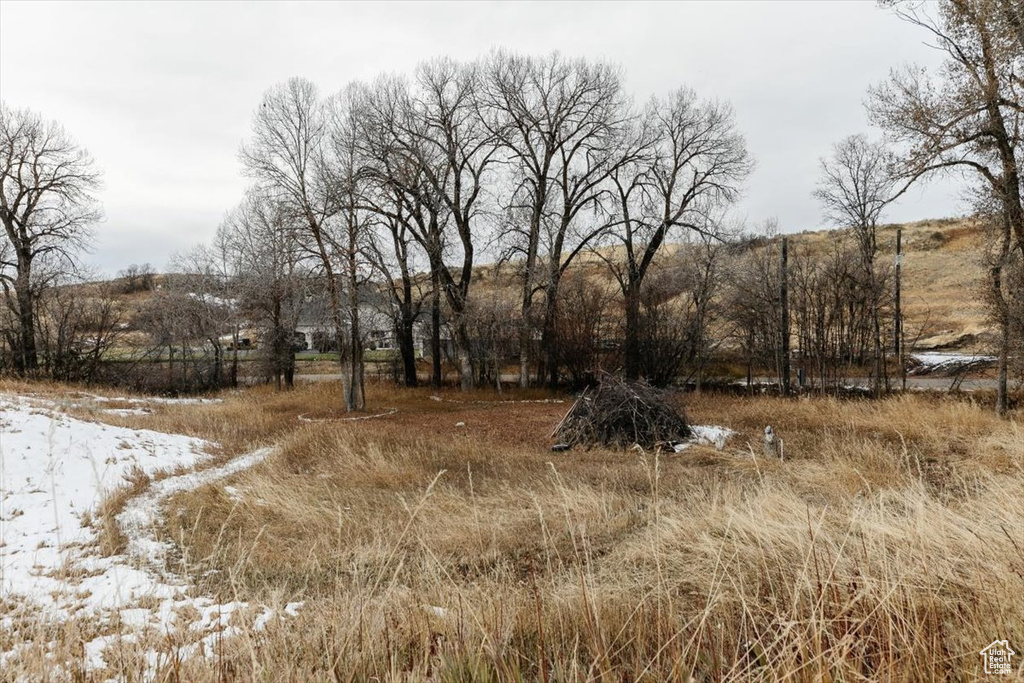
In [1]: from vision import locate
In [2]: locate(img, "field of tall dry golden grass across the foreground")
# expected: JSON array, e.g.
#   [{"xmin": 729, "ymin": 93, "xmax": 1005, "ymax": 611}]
[{"xmin": 0, "ymin": 384, "xmax": 1024, "ymax": 681}]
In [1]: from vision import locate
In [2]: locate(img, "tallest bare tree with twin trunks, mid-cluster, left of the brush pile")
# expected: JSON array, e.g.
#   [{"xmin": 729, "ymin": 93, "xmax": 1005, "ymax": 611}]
[{"xmin": 482, "ymin": 51, "xmax": 632, "ymax": 386}]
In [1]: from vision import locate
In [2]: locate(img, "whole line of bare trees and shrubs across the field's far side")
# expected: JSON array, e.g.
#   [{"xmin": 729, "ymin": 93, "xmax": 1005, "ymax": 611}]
[{"xmin": 0, "ymin": 0, "xmax": 1024, "ymax": 411}]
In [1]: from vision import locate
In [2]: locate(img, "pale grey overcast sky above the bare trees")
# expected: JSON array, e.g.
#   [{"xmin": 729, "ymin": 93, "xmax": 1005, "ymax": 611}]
[{"xmin": 0, "ymin": 0, "xmax": 962, "ymax": 274}]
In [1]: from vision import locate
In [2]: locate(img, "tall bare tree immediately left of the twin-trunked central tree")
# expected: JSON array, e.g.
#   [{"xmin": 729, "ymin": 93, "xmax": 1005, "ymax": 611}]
[{"xmin": 365, "ymin": 59, "xmax": 499, "ymax": 389}]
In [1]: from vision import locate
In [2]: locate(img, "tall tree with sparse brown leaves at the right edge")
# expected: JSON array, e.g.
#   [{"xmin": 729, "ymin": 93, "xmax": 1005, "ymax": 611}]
[{"xmin": 869, "ymin": 0, "xmax": 1024, "ymax": 414}]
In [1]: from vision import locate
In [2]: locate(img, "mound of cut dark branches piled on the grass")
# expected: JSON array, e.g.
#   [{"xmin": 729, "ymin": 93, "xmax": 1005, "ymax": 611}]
[{"xmin": 554, "ymin": 376, "xmax": 690, "ymax": 449}]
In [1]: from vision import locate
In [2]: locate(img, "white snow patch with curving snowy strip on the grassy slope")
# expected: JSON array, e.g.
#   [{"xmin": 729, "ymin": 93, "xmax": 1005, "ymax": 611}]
[{"xmin": 0, "ymin": 395, "xmax": 297, "ymax": 669}]
